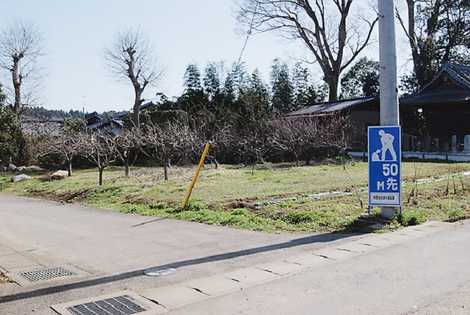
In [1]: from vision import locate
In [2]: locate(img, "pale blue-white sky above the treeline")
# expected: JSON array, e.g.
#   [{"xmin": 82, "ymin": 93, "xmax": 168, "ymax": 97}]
[{"xmin": 0, "ymin": 0, "xmax": 409, "ymax": 111}]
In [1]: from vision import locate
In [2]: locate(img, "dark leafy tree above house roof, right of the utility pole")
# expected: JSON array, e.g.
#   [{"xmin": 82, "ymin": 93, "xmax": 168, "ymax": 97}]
[{"xmin": 397, "ymin": 0, "xmax": 470, "ymax": 90}]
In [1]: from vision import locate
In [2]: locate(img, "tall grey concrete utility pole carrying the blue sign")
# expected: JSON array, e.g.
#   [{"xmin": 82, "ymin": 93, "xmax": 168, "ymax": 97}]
[{"xmin": 378, "ymin": 0, "xmax": 400, "ymax": 218}]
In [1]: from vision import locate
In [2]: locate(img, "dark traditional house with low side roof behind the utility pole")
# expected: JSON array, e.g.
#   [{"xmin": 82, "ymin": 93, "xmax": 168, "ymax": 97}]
[{"xmin": 286, "ymin": 64, "xmax": 470, "ymax": 158}]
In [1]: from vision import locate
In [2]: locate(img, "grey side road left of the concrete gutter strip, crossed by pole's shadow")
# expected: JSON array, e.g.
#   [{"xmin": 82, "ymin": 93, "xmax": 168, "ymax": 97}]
[{"xmin": 0, "ymin": 194, "xmax": 357, "ymax": 315}]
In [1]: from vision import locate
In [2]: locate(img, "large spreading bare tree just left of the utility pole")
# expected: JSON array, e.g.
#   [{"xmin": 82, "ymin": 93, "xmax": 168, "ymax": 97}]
[{"xmin": 239, "ymin": 0, "xmax": 378, "ymax": 101}]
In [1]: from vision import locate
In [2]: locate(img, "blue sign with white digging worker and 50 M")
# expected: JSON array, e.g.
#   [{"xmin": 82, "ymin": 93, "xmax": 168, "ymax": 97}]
[{"xmin": 369, "ymin": 126, "xmax": 401, "ymax": 207}]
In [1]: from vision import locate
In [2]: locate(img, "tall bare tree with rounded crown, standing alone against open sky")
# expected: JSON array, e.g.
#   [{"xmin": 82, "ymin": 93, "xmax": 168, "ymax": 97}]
[{"xmin": 105, "ymin": 30, "xmax": 162, "ymax": 127}]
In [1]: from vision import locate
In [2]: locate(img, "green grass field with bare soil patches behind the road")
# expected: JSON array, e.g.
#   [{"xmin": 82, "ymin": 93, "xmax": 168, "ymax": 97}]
[{"xmin": 0, "ymin": 163, "xmax": 470, "ymax": 232}]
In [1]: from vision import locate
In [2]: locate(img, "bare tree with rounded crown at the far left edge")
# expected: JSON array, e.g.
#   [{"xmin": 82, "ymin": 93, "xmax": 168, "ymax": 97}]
[{"xmin": 0, "ymin": 22, "xmax": 41, "ymax": 115}]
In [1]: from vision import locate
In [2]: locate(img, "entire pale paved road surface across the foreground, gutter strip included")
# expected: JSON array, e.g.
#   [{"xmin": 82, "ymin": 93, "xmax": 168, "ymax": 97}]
[{"xmin": 0, "ymin": 194, "xmax": 470, "ymax": 315}]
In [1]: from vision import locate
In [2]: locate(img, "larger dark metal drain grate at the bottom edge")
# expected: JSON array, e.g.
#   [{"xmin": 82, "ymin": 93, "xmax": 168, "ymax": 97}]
[{"xmin": 67, "ymin": 295, "xmax": 146, "ymax": 315}]
